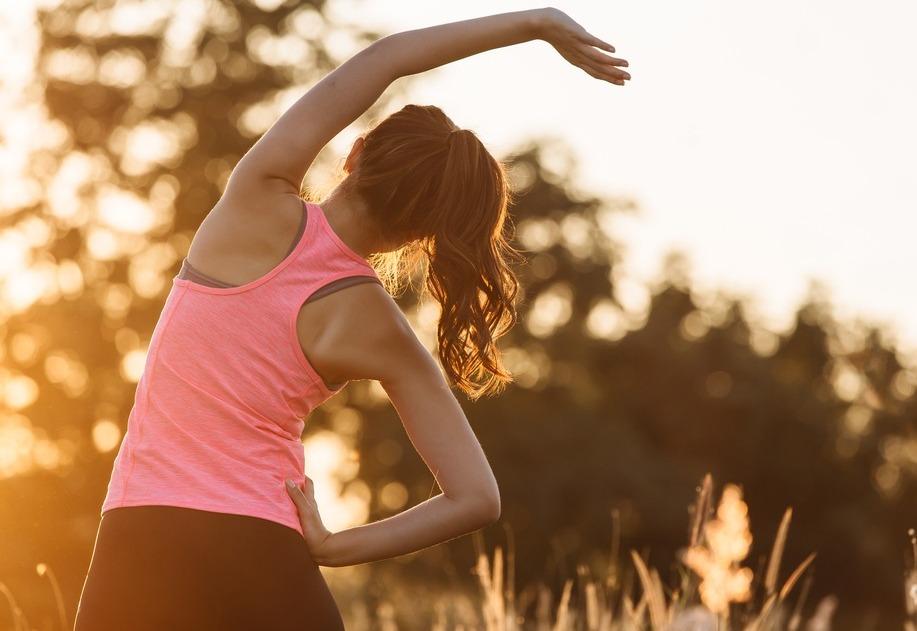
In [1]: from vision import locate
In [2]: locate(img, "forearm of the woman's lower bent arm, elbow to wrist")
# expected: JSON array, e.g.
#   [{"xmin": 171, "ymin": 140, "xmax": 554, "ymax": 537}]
[{"xmin": 315, "ymin": 493, "xmax": 494, "ymax": 567}]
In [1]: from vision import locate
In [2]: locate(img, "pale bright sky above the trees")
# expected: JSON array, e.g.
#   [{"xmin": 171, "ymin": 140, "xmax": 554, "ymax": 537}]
[{"xmin": 328, "ymin": 0, "xmax": 917, "ymax": 353}]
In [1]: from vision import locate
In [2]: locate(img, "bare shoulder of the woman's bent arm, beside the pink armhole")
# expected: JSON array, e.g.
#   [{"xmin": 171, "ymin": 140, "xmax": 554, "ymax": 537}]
[{"xmin": 311, "ymin": 282, "xmax": 441, "ymax": 384}]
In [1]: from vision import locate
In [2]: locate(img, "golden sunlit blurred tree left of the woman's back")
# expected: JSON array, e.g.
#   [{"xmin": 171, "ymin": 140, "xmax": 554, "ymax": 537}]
[{"xmin": 0, "ymin": 0, "xmax": 397, "ymax": 628}]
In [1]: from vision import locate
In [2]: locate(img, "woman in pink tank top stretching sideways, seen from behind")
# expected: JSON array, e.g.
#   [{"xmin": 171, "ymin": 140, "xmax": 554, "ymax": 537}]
[{"xmin": 76, "ymin": 8, "xmax": 630, "ymax": 631}]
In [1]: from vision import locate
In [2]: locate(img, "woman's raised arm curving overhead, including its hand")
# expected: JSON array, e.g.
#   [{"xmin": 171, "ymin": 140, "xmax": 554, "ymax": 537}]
[{"xmin": 226, "ymin": 8, "xmax": 629, "ymax": 202}]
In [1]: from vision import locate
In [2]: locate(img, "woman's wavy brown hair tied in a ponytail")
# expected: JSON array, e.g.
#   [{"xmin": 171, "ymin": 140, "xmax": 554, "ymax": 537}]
[{"xmin": 316, "ymin": 105, "xmax": 523, "ymax": 399}]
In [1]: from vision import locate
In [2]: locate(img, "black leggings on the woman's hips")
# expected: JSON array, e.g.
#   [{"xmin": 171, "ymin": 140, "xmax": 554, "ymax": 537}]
[{"xmin": 75, "ymin": 506, "xmax": 344, "ymax": 631}]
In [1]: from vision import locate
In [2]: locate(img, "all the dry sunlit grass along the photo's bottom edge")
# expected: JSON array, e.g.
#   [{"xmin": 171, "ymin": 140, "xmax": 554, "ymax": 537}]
[{"xmin": 0, "ymin": 475, "xmax": 917, "ymax": 631}]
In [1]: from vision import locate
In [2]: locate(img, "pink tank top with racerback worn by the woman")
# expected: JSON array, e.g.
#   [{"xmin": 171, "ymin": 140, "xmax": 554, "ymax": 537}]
[{"xmin": 101, "ymin": 201, "xmax": 379, "ymax": 534}]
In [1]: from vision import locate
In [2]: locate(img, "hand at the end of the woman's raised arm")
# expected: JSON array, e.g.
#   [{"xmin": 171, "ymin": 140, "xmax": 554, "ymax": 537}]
[{"xmin": 539, "ymin": 7, "xmax": 630, "ymax": 85}]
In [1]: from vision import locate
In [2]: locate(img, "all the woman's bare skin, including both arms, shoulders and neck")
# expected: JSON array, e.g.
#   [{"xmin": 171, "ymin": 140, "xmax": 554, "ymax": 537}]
[{"xmin": 188, "ymin": 8, "xmax": 630, "ymax": 566}]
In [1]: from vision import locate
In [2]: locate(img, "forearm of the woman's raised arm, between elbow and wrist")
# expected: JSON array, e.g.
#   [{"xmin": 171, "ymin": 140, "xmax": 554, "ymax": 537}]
[{"xmin": 375, "ymin": 9, "xmax": 543, "ymax": 79}]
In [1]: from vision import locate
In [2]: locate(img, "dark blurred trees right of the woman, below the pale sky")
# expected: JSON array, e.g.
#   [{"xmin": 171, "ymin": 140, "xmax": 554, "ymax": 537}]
[{"xmin": 358, "ymin": 142, "xmax": 917, "ymax": 629}]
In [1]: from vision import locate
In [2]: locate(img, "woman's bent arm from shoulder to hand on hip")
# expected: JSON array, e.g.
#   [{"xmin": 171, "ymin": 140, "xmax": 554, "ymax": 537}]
[{"xmin": 287, "ymin": 283, "xmax": 500, "ymax": 566}]
